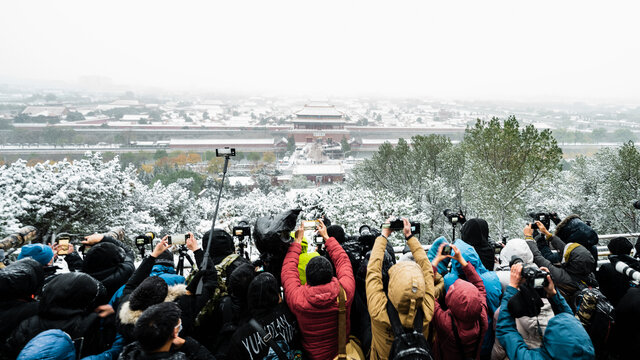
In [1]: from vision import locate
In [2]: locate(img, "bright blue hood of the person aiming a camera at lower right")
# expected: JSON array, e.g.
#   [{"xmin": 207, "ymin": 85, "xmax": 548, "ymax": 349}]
[{"xmin": 542, "ymin": 313, "xmax": 595, "ymax": 359}]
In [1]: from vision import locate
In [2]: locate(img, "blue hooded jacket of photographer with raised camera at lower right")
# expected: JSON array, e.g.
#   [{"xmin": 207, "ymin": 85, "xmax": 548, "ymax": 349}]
[{"xmin": 496, "ymin": 286, "xmax": 595, "ymax": 360}]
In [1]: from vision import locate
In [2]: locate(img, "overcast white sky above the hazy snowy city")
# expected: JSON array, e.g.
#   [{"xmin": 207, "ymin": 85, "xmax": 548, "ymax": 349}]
[{"xmin": 0, "ymin": 0, "xmax": 640, "ymax": 102}]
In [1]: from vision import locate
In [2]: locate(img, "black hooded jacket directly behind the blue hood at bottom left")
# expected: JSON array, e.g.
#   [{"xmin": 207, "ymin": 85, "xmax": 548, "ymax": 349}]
[{"xmin": 7, "ymin": 272, "xmax": 108, "ymax": 357}]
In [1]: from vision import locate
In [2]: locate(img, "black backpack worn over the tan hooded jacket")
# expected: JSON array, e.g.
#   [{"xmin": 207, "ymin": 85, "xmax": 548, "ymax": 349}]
[{"xmin": 387, "ymin": 300, "xmax": 433, "ymax": 360}]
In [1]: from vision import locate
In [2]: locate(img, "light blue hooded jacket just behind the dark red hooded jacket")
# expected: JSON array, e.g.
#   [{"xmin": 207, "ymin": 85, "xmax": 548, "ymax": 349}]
[{"xmin": 438, "ymin": 239, "xmax": 502, "ymax": 355}]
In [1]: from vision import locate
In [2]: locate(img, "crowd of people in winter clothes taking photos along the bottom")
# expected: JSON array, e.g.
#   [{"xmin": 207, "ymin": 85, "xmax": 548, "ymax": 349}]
[{"xmin": 0, "ymin": 212, "xmax": 640, "ymax": 360}]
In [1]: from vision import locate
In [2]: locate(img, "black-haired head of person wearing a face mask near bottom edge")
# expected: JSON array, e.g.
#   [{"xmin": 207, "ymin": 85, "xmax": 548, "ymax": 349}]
[{"xmin": 133, "ymin": 302, "xmax": 181, "ymax": 353}]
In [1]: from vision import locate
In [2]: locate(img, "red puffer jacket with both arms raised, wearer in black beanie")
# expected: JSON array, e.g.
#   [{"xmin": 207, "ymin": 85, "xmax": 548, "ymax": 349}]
[{"xmin": 282, "ymin": 237, "xmax": 356, "ymax": 360}]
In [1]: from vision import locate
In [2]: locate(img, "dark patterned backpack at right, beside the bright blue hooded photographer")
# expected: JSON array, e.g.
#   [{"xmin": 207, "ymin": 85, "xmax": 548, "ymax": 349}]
[{"xmin": 575, "ymin": 288, "xmax": 615, "ymax": 349}]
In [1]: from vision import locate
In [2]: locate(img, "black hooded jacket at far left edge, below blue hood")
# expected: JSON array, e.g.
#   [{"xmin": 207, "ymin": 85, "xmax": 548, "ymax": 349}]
[{"xmin": 0, "ymin": 258, "xmax": 44, "ymax": 342}]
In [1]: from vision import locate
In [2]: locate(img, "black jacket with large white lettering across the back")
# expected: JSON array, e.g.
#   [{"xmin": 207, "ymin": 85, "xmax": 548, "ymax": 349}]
[{"xmin": 228, "ymin": 303, "xmax": 300, "ymax": 360}]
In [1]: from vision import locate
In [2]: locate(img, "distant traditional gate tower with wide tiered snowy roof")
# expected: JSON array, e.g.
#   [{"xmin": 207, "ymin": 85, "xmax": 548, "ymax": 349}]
[{"xmin": 291, "ymin": 103, "xmax": 349, "ymax": 143}]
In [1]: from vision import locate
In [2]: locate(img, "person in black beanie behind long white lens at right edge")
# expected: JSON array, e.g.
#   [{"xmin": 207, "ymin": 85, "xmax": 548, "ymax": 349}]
[{"xmin": 596, "ymin": 237, "xmax": 640, "ymax": 307}]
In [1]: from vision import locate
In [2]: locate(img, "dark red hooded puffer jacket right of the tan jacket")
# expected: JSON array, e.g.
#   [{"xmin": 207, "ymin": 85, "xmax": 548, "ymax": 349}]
[{"xmin": 433, "ymin": 263, "xmax": 489, "ymax": 360}]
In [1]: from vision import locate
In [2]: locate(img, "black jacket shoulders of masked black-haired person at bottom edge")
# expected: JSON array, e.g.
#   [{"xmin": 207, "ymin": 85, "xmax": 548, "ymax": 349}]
[{"xmin": 118, "ymin": 337, "xmax": 215, "ymax": 360}]
